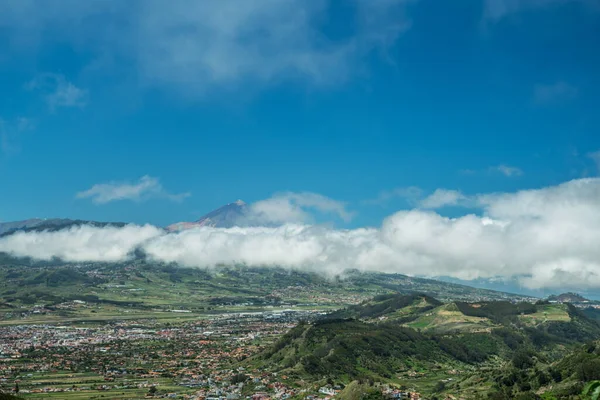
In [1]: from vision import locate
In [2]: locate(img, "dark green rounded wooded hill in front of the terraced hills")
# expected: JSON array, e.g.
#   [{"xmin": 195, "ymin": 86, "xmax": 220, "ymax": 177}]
[{"xmin": 251, "ymin": 319, "xmax": 449, "ymax": 380}]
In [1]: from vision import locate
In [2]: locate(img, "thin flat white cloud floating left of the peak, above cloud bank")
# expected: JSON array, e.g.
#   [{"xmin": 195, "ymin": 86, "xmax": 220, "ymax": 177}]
[{"xmin": 76, "ymin": 175, "xmax": 190, "ymax": 204}]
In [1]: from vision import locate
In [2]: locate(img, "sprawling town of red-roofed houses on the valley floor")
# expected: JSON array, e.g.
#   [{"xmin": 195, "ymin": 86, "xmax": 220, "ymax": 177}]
[{"xmin": 0, "ymin": 310, "xmax": 328, "ymax": 400}]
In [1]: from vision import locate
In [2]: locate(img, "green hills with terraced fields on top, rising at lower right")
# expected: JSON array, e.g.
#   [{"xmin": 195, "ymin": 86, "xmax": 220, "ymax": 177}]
[{"xmin": 247, "ymin": 295, "xmax": 600, "ymax": 399}]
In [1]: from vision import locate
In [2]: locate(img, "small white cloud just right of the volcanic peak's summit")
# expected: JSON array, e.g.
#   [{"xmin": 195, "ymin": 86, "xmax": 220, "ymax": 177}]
[{"xmin": 249, "ymin": 192, "xmax": 352, "ymax": 224}]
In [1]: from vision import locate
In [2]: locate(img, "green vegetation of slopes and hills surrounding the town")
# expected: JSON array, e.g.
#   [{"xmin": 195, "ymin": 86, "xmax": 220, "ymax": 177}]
[{"xmin": 0, "ymin": 256, "xmax": 600, "ymax": 400}]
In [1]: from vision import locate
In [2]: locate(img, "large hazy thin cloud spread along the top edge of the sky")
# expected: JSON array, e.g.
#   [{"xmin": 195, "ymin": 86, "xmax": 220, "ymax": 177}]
[{"xmin": 0, "ymin": 0, "xmax": 411, "ymax": 94}]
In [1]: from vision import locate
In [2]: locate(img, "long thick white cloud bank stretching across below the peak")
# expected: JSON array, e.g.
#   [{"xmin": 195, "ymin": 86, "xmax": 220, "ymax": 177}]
[{"xmin": 5, "ymin": 178, "xmax": 600, "ymax": 289}]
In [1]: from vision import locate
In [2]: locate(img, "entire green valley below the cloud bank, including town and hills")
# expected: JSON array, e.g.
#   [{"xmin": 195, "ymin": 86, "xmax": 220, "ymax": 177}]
[{"xmin": 0, "ymin": 259, "xmax": 600, "ymax": 399}]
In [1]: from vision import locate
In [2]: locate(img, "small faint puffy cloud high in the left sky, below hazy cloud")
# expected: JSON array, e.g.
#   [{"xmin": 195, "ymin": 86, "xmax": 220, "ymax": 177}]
[{"xmin": 26, "ymin": 73, "xmax": 88, "ymax": 111}]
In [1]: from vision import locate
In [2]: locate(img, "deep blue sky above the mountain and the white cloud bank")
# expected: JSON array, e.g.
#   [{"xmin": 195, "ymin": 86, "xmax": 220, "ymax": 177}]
[{"xmin": 0, "ymin": 0, "xmax": 600, "ymax": 227}]
